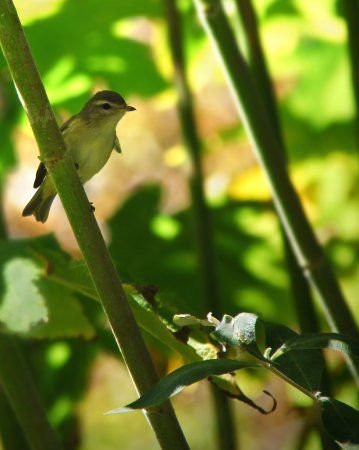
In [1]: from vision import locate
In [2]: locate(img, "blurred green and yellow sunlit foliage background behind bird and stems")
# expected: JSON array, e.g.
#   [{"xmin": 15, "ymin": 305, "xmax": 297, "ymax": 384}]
[{"xmin": 0, "ymin": 0, "xmax": 359, "ymax": 450}]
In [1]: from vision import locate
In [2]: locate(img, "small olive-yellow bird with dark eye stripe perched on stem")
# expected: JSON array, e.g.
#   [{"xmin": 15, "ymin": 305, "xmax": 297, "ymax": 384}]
[{"xmin": 22, "ymin": 91, "xmax": 136, "ymax": 222}]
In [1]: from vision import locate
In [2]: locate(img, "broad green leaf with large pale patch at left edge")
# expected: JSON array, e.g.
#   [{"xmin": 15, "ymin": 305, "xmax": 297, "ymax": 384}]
[{"xmin": 0, "ymin": 236, "xmax": 94, "ymax": 338}]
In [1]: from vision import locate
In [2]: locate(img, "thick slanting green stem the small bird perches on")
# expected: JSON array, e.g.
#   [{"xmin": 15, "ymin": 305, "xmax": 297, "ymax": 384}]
[{"xmin": 0, "ymin": 0, "xmax": 188, "ymax": 450}]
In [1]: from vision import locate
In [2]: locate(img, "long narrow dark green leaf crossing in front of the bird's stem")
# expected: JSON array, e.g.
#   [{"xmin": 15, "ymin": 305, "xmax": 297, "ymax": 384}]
[{"xmin": 106, "ymin": 359, "xmax": 260, "ymax": 414}]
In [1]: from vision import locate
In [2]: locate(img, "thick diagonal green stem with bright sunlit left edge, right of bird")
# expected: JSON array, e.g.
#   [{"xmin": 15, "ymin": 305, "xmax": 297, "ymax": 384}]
[{"xmin": 195, "ymin": 0, "xmax": 359, "ymax": 385}]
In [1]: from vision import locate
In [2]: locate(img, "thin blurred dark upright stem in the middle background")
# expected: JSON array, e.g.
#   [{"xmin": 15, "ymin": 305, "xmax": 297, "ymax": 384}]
[{"xmin": 165, "ymin": 0, "xmax": 236, "ymax": 450}]
